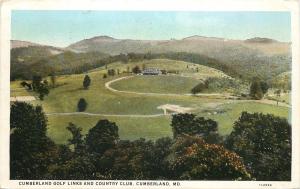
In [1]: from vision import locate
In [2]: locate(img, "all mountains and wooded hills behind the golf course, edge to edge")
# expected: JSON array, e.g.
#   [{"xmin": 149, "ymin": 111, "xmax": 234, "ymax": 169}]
[{"xmin": 11, "ymin": 35, "xmax": 291, "ymax": 80}]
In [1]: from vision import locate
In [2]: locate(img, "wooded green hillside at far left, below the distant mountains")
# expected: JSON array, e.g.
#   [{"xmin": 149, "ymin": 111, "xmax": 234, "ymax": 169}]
[{"xmin": 11, "ymin": 46, "xmax": 107, "ymax": 80}]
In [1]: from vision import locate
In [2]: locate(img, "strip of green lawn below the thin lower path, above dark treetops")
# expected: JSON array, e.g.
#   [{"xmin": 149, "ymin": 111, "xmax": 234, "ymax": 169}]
[{"xmin": 48, "ymin": 115, "xmax": 172, "ymax": 143}]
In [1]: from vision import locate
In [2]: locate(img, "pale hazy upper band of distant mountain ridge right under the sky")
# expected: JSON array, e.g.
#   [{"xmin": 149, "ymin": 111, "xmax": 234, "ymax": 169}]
[{"xmin": 66, "ymin": 35, "xmax": 290, "ymax": 56}]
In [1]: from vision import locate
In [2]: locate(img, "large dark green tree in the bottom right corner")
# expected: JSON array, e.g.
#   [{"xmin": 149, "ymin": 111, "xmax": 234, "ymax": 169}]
[{"xmin": 225, "ymin": 112, "xmax": 291, "ymax": 181}]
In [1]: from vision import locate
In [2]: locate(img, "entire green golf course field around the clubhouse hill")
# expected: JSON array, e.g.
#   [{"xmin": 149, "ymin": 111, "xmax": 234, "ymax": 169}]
[{"xmin": 11, "ymin": 59, "xmax": 289, "ymax": 143}]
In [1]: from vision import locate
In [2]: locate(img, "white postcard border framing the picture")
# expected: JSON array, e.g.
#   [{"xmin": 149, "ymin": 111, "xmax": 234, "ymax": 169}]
[{"xmin": 0, "ymin": 0, "xmax": 300, "ymax": 188}]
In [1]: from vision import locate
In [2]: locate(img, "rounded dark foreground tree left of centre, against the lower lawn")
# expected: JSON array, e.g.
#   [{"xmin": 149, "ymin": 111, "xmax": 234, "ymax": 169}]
[{"xmin": 85, "ymin": 119, "xmax": 119, "ymax": 154}]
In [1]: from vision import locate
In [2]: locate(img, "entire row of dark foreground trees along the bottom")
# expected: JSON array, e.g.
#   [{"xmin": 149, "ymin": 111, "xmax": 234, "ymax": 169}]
[{"xmin": 10, "ymin": 102, "xmax": 291, "ymax": 180}]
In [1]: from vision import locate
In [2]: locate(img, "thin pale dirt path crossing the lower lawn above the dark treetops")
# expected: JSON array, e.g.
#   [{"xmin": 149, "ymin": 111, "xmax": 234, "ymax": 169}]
[{"xmin": 46, "ymin": 112, "xmax": 169, "ymax": 118}]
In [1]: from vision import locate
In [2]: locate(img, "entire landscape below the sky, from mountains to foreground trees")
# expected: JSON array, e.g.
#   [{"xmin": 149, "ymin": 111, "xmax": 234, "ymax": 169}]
[{"xmin": 10, "ymin": 11, "xmax": 292, "ymax": 181}]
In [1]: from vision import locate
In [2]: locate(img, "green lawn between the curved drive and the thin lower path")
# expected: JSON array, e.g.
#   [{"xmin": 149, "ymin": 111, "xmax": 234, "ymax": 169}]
[{"xmin": 30, "ymin": 72, "xmax": 226, "ymax": 114}]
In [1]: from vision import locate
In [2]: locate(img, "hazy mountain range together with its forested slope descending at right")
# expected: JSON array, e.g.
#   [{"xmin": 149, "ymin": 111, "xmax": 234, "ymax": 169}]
[{"xmin": 66, "ymin": 35, "xmax": 291, "ymax": 77}]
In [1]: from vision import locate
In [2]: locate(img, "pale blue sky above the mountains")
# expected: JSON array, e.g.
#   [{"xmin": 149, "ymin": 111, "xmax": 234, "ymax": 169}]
[{"xmin": 11, "ymin": 10, "xmax": 291, "ymax": 47}]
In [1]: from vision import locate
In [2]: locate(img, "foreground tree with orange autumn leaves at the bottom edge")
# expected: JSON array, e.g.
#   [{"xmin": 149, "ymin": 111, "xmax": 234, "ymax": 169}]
[{"xmin": 169, "ymin": 136, "xmax": 251, "ymax": 180}]
